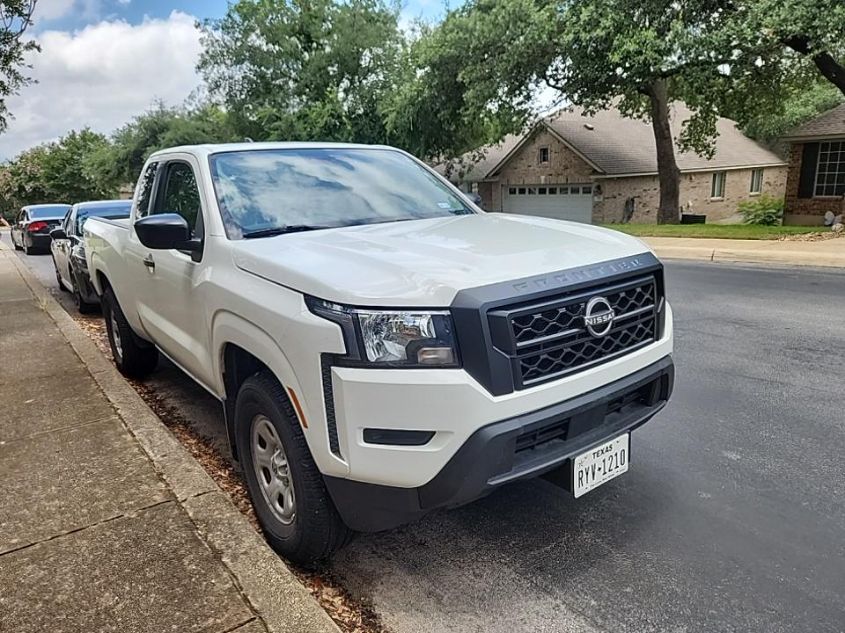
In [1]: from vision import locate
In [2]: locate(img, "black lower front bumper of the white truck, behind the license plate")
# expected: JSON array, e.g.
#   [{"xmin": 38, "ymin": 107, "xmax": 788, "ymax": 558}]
[{"xmin": 325, "ymin": 355, "xmax": 674, "ymax": 532}]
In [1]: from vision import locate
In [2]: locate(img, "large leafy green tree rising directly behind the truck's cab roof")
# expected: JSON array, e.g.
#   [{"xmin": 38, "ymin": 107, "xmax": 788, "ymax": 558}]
[{"xmin": 199, "ymin": 0, "xmax": 403, "ymax": 142}]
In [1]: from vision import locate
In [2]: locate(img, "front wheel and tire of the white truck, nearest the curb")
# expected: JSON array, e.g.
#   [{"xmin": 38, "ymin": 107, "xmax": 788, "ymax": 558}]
[{"xmin": 235, "ymin": 370, "xmax": 352, "ymax": 567}]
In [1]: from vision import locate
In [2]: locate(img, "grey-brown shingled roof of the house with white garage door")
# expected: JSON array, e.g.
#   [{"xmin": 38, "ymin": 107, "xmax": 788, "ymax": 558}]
[{"xmin": 448, "ymin": 103, "xmax": 786, "ymax": 181}]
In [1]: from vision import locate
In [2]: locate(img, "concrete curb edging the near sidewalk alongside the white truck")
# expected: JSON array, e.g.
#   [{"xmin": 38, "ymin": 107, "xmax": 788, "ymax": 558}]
[{"xmin": 0, "ymin": 242, "xmax": 340, "ymax": 633}]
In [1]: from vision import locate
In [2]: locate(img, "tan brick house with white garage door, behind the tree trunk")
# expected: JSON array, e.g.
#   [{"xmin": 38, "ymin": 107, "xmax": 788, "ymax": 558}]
[{"xmin": 438, "ymin": 104, "xmax": 787, "ymax": 223}]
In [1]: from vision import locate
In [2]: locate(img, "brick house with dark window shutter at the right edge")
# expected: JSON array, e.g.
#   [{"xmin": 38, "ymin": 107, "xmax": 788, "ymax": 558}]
[{"xmin": 783, "ymin": 103, "xmax": 845, "ymax": 225}]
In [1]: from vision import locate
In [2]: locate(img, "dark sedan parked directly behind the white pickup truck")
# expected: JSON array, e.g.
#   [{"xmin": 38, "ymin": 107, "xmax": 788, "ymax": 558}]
[{"xmin": 50, "ymin": 200, "xmax": 132, "ymax": 314}]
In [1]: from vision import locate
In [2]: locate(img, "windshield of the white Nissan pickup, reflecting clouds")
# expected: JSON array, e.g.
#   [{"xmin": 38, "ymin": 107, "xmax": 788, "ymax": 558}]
[{"xmin": 210, "ymin": 148, "xmax": 474, "ymax": 239}]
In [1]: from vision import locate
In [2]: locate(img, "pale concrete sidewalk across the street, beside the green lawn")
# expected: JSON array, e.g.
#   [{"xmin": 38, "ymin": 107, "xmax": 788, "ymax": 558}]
[{"xmin": 643, "ymin": 237, "xmax": 845, "ymax": 268}]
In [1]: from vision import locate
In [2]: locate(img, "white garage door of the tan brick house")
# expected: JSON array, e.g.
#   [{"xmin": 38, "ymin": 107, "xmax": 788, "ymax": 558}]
[{"xmin": 502, "ymin": 185, "xmax": 593, "ymax": 223}]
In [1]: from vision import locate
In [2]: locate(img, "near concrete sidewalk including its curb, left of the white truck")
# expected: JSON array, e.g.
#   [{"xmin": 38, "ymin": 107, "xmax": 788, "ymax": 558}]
[{"xmin": 0, "ymin": 238, "xmax": 338, "ymax": 633}]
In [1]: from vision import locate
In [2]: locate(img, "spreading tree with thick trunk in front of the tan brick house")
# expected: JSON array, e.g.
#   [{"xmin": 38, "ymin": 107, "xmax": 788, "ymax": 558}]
[{"xmin": 392, "ymin": 0, "xmax": 763, "ymax": 222}]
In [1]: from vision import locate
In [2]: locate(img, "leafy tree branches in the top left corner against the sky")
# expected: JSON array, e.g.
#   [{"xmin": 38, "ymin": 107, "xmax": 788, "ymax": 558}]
[{"xmin": 0, "ymin": 0, "xmax": 38, "ymax": 132}]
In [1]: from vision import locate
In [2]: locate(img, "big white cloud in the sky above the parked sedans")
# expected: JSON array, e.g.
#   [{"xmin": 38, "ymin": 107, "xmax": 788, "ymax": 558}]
[{"xmin": 0, "ymin": 10, "xmax": 201, "ymax": 159}]
